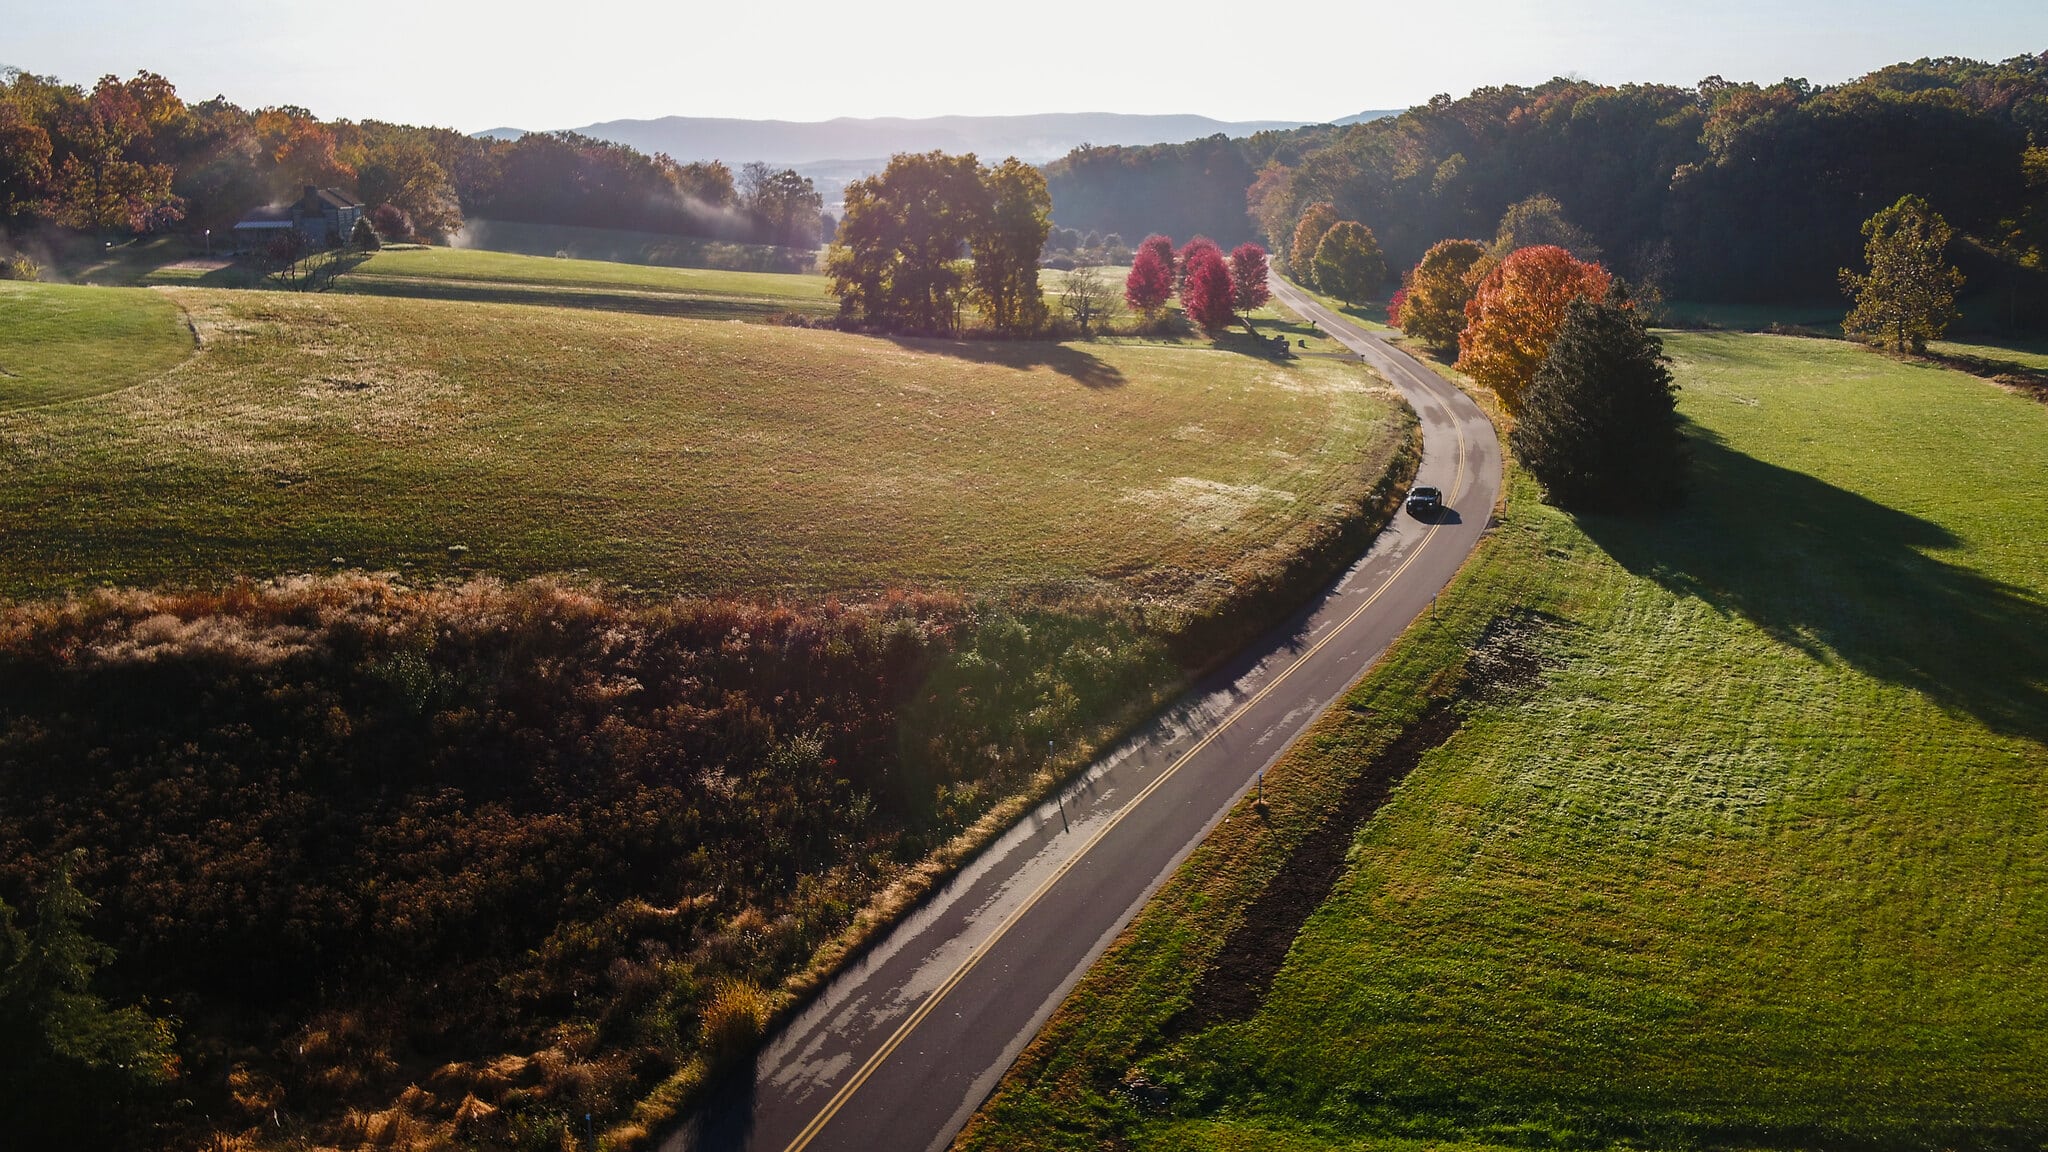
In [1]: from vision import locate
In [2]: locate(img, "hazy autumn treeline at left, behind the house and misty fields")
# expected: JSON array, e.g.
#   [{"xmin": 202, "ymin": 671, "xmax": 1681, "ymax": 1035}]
[{"xmin": 0, "ymin": 70, "xmax": 831, "ymax": 248}]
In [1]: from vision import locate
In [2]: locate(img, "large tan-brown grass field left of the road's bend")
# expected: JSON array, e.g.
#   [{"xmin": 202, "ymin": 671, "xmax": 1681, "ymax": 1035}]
[{"xmin": 0, "ymin": 280, "xmax": 1405, "ymax": 594}]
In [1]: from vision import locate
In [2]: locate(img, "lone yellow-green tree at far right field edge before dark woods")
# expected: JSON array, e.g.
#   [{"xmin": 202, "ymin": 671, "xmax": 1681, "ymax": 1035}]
[{"xmin": 1841, "ymin": 197, "xmax": 1962, "ymax": 353}]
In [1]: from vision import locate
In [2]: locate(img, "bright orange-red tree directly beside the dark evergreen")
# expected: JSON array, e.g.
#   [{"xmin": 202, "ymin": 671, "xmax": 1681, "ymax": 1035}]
[{"xmin": 1458, "ymin": 244, "xmax": 1614, "ymax": 416}]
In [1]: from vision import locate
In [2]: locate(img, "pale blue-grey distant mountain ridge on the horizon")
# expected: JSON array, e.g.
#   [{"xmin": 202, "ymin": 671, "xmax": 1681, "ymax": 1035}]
[{"xmin": 477, "ymin": 111, "xmax": 1397, "ymax": 168}]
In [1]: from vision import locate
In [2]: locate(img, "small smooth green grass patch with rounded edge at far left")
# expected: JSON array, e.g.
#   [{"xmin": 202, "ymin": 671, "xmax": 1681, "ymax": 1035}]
[{"xmin": 0, "ymin": 283, "xmax": 193, "ymax": 412}]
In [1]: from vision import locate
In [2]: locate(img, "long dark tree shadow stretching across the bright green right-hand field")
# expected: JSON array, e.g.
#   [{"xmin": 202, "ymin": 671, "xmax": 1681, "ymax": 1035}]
[{"xmin": 1579, "ymin": 426, "xmax": 2048, "ymax": 742}]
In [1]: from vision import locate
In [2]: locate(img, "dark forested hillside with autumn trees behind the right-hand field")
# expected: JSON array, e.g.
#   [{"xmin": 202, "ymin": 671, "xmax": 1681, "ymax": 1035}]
[{"xmin": 1049, "ymin": 53, "xmax": 2048, "ymax": 313}]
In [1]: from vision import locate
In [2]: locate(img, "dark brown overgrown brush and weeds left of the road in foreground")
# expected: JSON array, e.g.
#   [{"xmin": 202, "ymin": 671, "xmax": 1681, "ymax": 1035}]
[{"xmin": 0, "ymin": 578, "xmax": 1178, "ymax": 1146}]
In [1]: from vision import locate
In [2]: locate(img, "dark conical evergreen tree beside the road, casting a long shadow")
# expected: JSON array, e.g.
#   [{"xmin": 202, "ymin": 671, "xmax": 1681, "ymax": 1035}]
[{"xmin": 1507, "ymin": 297, "xmax": 1686, "ymax": 512}]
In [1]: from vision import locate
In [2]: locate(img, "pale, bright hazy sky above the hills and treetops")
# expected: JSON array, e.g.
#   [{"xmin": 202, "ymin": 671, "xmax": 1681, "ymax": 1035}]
[{"xmin": 0, "ymin": 0, "xmax": 2048, "ymax": 131}]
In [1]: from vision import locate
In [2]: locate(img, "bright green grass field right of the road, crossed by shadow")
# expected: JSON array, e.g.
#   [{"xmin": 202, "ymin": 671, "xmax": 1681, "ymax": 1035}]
[{"xmin": 961, "ymin": 334, "xmax": 2048, "ymax": 1150}]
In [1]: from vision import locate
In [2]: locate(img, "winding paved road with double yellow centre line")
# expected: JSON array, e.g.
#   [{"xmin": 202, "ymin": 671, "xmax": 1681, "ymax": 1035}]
[{"xmin": 664, "ymin": 279, "xmax": 1501, "ymax": 1152}]
